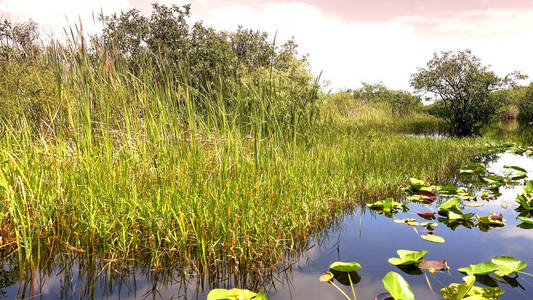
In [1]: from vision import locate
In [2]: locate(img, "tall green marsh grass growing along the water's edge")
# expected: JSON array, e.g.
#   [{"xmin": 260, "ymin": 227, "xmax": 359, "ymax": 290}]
[{"xmin": 0, "ymin": 38, "xmax": 483, "ymax": 271}]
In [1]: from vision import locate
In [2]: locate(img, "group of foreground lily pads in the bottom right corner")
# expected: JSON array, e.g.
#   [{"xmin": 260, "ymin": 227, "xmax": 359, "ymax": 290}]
[{"xmin": 320, "ymin": 250, "xmax": 533, "ymax": 300}]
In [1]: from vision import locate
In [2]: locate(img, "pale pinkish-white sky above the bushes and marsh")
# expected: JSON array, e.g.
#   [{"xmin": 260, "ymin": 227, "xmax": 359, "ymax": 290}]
[{"xmin": 0, "ymin": 0, "xmax": 533, "ymax": 90}]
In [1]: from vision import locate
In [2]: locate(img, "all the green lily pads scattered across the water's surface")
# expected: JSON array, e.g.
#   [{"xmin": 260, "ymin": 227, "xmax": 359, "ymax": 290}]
[{"xmin": 207, "ymin": 144, "xmax": 533, "ymax": 300}]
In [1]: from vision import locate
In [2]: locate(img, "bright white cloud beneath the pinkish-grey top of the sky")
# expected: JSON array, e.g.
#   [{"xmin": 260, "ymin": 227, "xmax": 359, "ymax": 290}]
[{"xmin": 0, "ymin": 0, "xmax": 533, "ymax": 89}]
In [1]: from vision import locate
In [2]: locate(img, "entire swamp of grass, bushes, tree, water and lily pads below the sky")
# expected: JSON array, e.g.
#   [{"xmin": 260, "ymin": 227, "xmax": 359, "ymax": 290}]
[{"xmin": 0, "ymin": 4, "xmax": 533, "ymax": 300}]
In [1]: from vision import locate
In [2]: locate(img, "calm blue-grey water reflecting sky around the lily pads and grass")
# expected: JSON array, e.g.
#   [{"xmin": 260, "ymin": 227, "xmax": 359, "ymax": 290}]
[{"xmin": 0, "ymin": 154, "xmax": 533, "ymax": 300}]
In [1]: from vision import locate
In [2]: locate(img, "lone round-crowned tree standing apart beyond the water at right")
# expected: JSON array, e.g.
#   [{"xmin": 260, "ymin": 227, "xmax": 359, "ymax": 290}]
[{"xmin": 411, "ymin": 50, "xmax": 524, "ymax": 136}]
